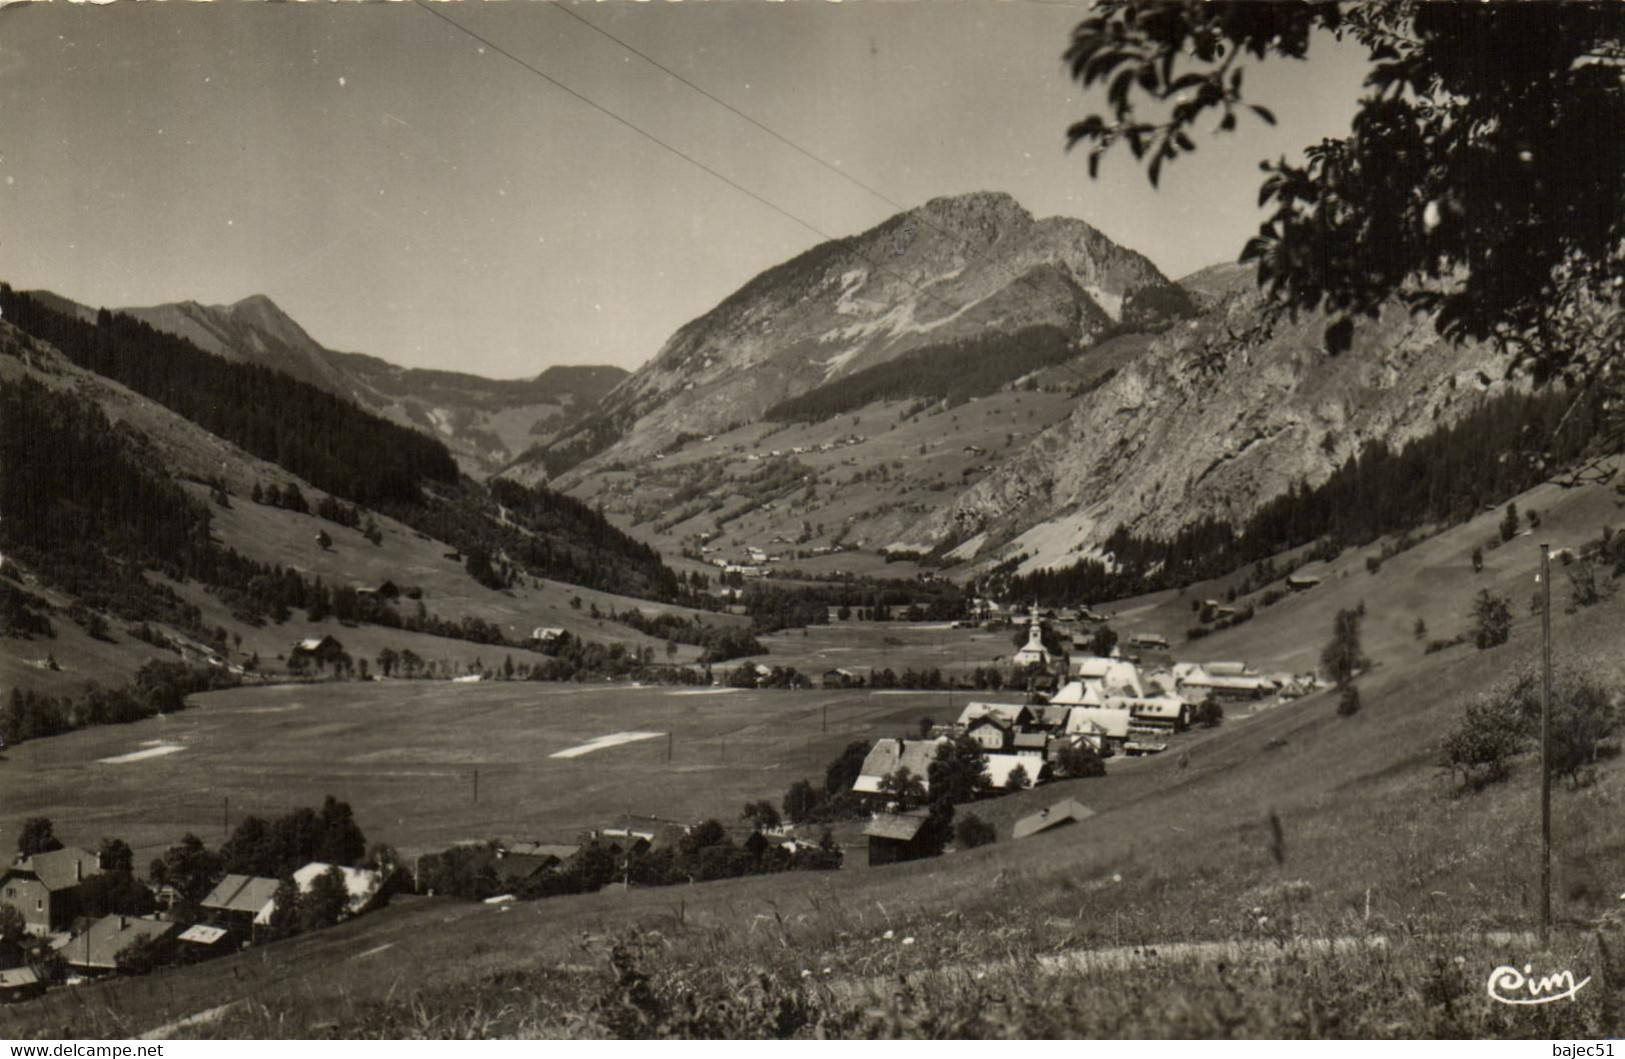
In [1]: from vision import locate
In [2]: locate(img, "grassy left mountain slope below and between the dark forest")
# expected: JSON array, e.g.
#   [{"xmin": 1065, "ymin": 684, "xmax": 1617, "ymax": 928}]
[{"xmin": 0, "ymin": 315, "xmax": 730, "ymax": 695}]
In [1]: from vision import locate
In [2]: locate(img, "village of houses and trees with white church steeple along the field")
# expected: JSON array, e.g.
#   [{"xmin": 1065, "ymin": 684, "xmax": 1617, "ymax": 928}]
[{"xmin": 0, "ymin": 601, "xmax": 1316, "ymax": 1001}]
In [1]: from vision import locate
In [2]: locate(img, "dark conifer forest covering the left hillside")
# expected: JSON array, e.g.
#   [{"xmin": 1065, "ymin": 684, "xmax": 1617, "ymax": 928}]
[{"xmin": 0, "ymin": 284, "xmax": 679, "ymax": 604}]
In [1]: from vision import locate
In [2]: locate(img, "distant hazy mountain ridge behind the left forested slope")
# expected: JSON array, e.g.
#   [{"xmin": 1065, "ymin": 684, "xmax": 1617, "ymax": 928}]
[{"xmin": 33, "ymin": 291, "xmax": 627, "ymax": 476}]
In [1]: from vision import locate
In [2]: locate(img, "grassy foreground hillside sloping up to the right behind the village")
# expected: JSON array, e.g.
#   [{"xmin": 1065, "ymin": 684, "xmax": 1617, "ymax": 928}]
[{"xmin": 13, "ymin": 467, "xmax": 1625, "ymax": 1038}]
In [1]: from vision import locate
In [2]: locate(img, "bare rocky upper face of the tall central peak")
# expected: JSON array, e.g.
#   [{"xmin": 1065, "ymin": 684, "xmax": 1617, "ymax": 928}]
[{"xmin": 539, "ymin": 193, "xmax": 1190, "ymax": 481}]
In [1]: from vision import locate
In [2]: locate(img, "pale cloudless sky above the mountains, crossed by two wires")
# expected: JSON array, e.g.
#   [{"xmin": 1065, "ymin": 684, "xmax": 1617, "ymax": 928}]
[{"xmin": 0, "ymin": 0, "xmax": 1363, "ymax": 378}]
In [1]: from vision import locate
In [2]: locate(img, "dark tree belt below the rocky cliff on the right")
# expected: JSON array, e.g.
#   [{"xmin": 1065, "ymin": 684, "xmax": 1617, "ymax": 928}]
[{"xmin": 990, "ymin": 390, "xmax": 1604, "ymax": 603}]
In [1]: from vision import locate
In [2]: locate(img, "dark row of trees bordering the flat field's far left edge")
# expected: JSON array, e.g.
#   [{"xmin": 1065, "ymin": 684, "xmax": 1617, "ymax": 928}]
[{"xmin": 0, "ymin": 658, "xmax": 241, "ymax": 746}]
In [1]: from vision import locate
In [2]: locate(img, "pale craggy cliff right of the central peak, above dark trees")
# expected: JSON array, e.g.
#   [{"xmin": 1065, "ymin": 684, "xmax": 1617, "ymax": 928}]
[{"xmin": 912, "ymin": 266, "xmax": 1505, "ymax": 570}]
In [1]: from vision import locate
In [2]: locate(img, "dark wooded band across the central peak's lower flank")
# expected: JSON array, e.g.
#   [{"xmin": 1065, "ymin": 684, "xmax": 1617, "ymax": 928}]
[{"xmin": 762, "ymin": 325, "xmax": 1079, "ymax": 422}]
